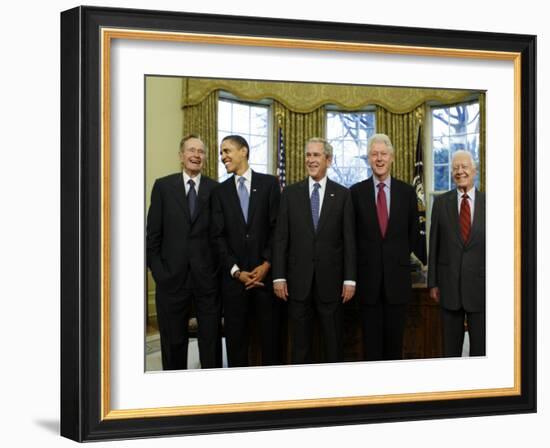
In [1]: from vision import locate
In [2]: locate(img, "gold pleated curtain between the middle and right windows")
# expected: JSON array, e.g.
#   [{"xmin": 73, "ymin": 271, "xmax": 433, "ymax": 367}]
[{"xmin": 376, "ymin": 106, "xmax": 424, "ymax": 184}]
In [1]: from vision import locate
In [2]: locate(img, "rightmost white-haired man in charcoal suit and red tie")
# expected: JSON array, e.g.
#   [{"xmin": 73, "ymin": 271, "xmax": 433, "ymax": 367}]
[{"xmin": 428, "ymin": 151, "xmax": 485, "ymax": 356}]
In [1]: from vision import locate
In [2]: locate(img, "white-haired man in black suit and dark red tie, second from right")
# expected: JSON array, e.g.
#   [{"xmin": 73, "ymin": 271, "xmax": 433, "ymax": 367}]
[{"xmin": 351, "ymin": 134, "xmax": 419, "ymax": 361}]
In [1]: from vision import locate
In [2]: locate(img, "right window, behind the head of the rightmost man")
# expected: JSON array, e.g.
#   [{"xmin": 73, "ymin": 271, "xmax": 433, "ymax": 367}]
[{"xmin": 431, "ymin": 102, "xmax": 479, "ymax": 193}]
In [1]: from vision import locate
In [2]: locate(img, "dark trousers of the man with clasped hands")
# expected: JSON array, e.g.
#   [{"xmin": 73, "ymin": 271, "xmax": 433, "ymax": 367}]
[{"xmin": 223, "ymin": 280, "xmax": 281, "ymax": 367}]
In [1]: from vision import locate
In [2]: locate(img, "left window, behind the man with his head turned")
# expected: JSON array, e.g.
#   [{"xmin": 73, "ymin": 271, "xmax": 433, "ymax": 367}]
[{"xmin": 218, "ymin": 99, "xmax": 271, "ymax": 182}]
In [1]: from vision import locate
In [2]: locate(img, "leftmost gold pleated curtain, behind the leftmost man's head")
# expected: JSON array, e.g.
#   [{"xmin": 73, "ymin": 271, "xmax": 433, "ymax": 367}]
[{"xmin": 183, "ymin": 89, "xmax": 218, "ymax": 179}]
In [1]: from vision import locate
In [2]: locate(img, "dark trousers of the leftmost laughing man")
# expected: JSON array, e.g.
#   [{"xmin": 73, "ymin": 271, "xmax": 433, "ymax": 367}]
[{"xmin": 155, "ymin": 273, "xmax": 221, "ymax": 370}]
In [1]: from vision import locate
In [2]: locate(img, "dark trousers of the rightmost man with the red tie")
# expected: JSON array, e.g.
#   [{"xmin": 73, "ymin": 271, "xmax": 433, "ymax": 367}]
[{"xmin": 441, "ymin": 308, "xmax": 485, "ymax": 357}]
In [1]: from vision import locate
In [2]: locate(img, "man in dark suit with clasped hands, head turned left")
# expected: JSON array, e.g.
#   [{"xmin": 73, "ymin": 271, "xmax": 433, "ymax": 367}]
[{"xmin": 212, "ymin": 135, "xmax": 281, "ymax": 367}]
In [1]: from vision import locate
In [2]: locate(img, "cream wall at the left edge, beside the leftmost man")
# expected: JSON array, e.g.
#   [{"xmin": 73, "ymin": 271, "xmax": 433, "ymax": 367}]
[{"xmin": 145, "ymin": 77, "xmax": 183, "ymax": 316}]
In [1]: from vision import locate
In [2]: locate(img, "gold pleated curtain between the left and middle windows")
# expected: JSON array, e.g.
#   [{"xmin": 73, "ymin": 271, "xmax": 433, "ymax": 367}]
[{"xmin": 273, "ymin": 101, "xmax": 326, "ymax": 185}]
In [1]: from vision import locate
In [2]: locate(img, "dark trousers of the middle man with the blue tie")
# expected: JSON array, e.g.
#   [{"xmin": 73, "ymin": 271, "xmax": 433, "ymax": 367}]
[{"xmin": 288, "ymin": 277, "xmax": 344, "ymax": 364}]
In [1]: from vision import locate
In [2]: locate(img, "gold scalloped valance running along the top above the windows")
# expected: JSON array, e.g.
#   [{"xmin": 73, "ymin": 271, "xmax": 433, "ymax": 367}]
[{"xmin": 182, "ymin": 78, "xmax": 472, "ymax": 114}]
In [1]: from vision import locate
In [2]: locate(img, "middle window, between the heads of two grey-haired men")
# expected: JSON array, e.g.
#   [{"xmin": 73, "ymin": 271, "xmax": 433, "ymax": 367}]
[{"xmin": 327, "ymin": 111, "xmax": 375, "ymax": 187}]
